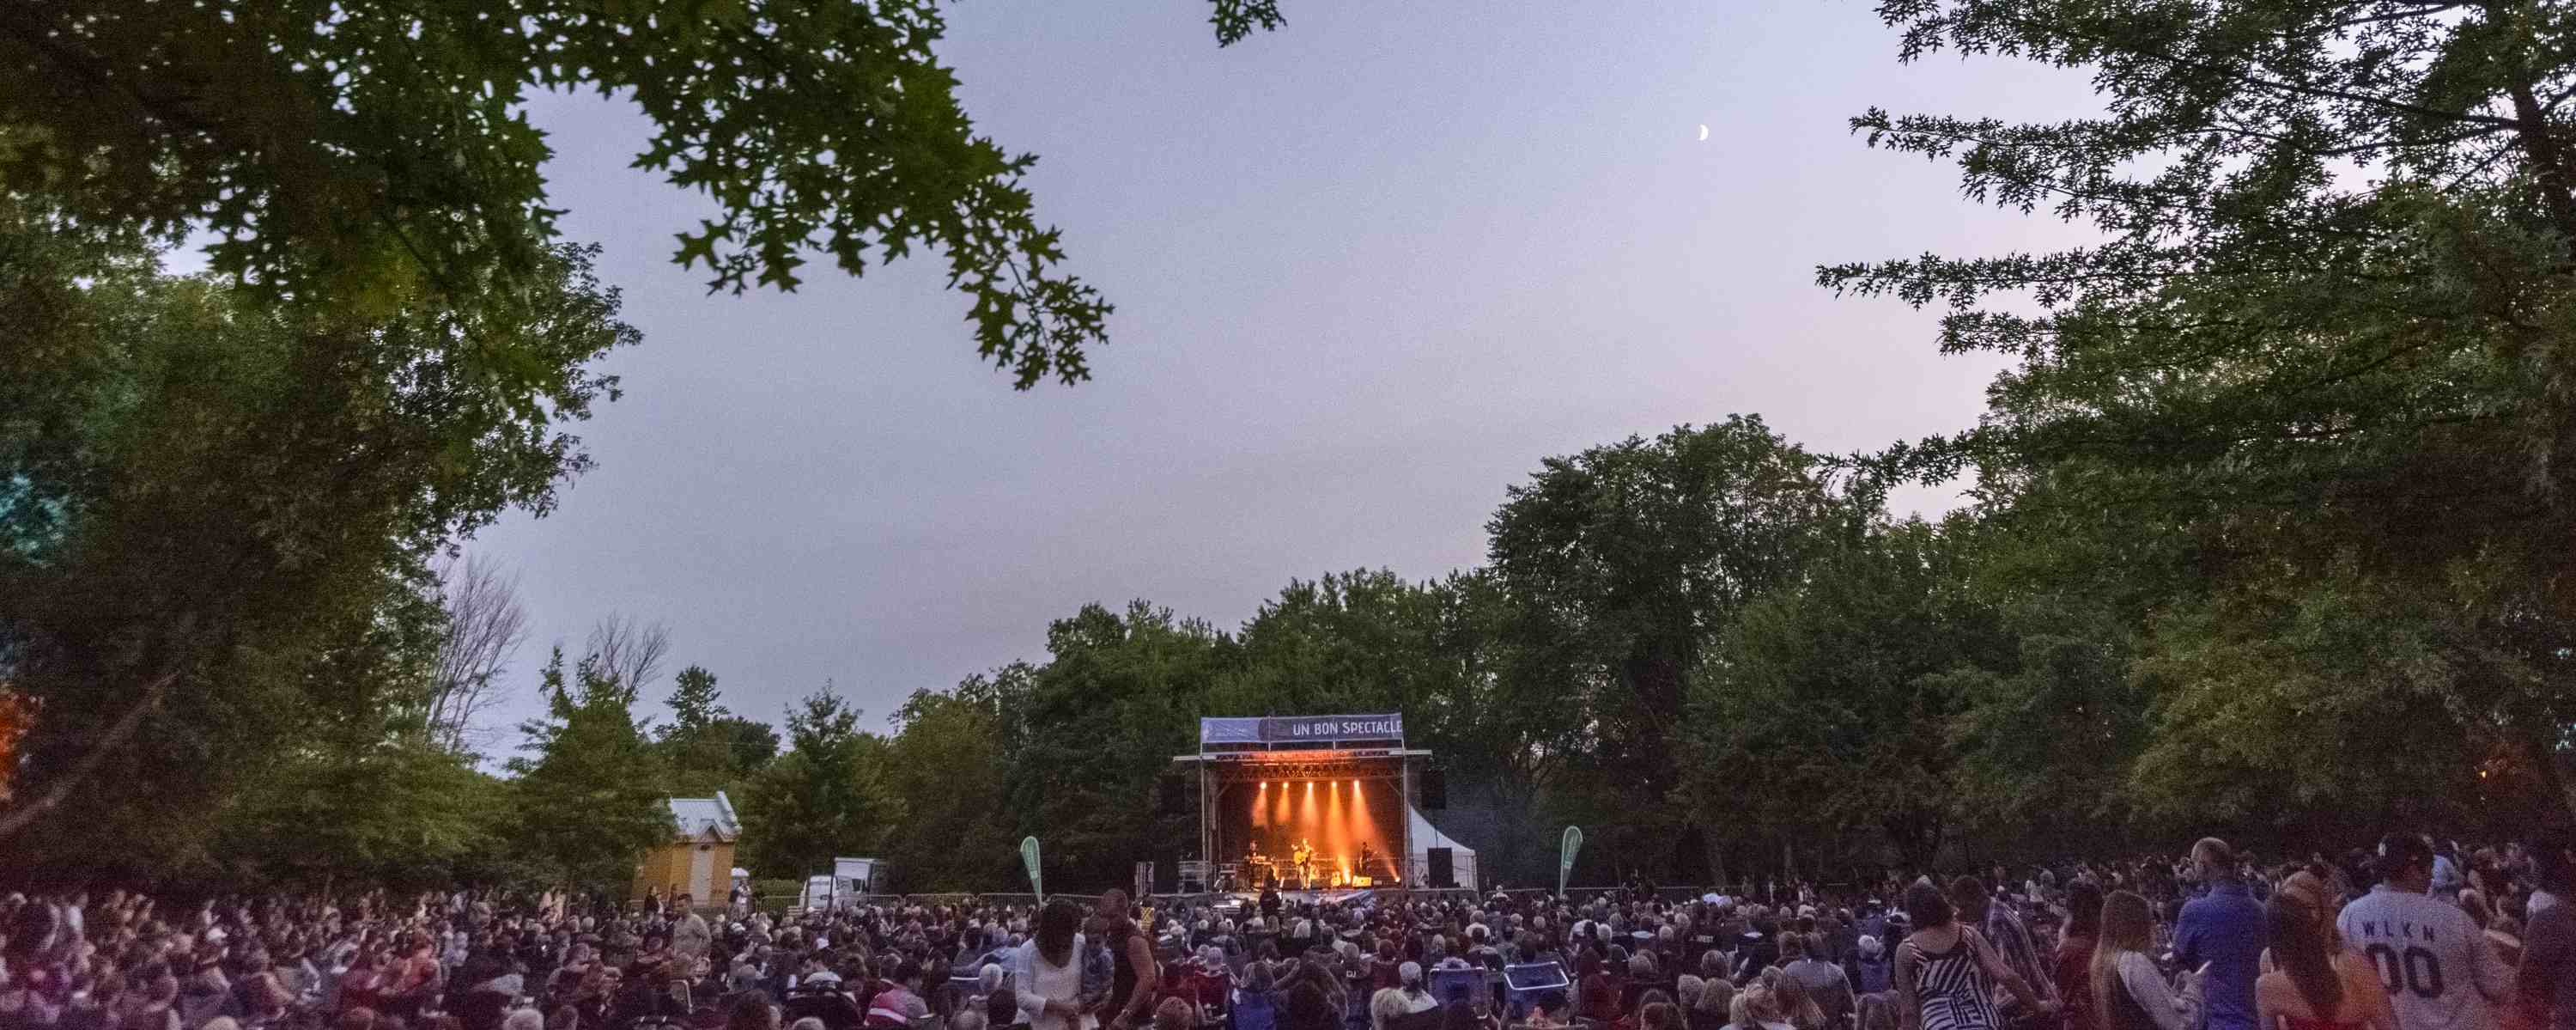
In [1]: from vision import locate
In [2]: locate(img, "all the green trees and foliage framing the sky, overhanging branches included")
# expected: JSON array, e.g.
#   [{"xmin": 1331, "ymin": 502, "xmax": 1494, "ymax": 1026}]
[{"xmin": 0, "ymin": 0, "xmax": 2576, "ymax": 888}]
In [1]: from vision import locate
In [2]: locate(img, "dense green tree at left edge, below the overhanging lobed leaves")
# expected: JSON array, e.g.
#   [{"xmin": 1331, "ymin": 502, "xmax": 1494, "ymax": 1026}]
[{"xmin": 0, "ymin": 201, "xmax": 634, "ymax": 855}]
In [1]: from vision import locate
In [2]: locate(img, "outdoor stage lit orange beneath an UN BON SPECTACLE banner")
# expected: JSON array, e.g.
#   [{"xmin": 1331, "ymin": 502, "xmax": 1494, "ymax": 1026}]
[{"xmin": 1172, "ymin": 716, "xmax": 1476, "ymax": 899}]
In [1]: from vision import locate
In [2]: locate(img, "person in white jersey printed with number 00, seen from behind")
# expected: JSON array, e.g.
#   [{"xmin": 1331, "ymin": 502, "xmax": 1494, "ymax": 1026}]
[{"xmin": 2336, "ymin": 834, "xmax": 2514, "ymax": 1030}]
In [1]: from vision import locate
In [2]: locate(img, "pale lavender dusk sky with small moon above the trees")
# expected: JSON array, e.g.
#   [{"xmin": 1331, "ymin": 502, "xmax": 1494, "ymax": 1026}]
[{"xmin": 469, "ymin": 0, "xmax": 2092, "ymax": 749}]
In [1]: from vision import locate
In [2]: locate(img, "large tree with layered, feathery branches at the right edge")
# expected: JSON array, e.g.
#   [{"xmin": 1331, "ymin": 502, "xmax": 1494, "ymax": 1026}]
[{"xmin": 1819, "ymin": 0, "xmax": 2576, "ymax": 808}]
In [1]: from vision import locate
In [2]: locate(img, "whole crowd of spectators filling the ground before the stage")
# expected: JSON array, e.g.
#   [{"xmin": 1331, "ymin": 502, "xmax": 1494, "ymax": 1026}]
[{"xmin": 0, "ymin": 834, "xmax": 2576, "ymax": 1030}]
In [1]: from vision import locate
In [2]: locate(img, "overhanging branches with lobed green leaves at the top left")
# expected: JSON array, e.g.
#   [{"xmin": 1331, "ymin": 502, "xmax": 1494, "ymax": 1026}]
[{"xmin": 0, "ymin": 0, "xmax": 1280, "ymax": 389}]
